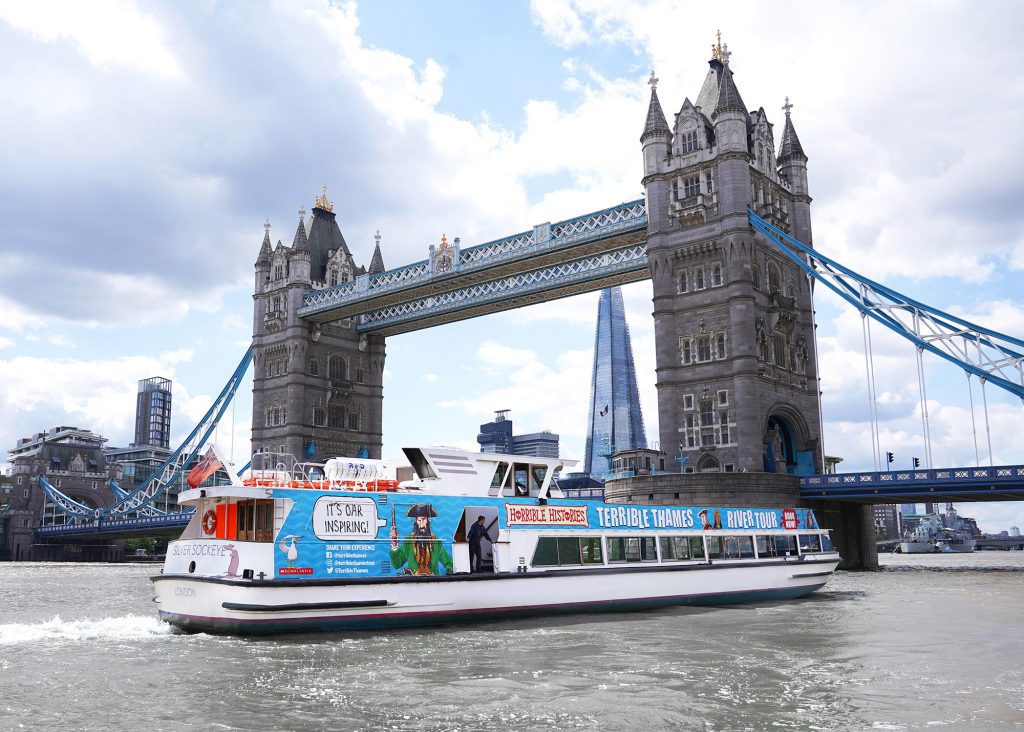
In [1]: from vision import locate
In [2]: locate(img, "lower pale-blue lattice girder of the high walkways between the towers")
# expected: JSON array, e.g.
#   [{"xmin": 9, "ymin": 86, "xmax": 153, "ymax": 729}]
[{"xmin": 356, "ymin": 244, "xmax": 649, "ymax": 333}]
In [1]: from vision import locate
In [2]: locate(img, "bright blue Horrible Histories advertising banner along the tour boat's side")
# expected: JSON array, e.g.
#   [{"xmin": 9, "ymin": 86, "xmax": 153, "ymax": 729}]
[{"xmin": 274, "ymin": 489, "xmax": 817, "ymax": 578}]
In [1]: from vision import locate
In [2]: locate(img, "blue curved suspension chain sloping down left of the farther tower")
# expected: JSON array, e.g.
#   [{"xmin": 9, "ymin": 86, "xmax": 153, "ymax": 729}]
[{"xmin": 40, "ymin": 347, "xmax": 253, "ymax": 520}]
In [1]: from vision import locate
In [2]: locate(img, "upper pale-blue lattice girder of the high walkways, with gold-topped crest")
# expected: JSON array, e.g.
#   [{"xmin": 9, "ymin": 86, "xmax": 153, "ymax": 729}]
[{"xmin": 298, "ymin": 199, "xmax": 647, "ymax": 317}]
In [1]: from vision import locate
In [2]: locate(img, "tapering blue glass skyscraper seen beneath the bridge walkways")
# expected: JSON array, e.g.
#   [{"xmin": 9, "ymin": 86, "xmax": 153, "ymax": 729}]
[{"xmin": 584, "ymin": 287, "xmax": 647, "ymax": 480}]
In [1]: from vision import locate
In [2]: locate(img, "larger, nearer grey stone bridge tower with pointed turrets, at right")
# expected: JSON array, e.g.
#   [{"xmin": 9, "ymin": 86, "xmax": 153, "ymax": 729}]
[{"xmin": 640, "ymin": 40, "xmax": 822, "ymax": 474}]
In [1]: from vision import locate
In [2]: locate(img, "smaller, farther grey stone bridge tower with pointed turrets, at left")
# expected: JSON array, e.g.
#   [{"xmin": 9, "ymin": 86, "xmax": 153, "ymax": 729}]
[{"xmin": 252, "ymin": 186, "xmax": 385, "ymax": 462}]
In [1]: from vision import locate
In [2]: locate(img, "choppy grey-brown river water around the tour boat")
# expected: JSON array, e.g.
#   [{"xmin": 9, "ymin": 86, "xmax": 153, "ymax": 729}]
[{"xmin": 0, "ymin": 552, "xmax": 1024, "ymax": 732}]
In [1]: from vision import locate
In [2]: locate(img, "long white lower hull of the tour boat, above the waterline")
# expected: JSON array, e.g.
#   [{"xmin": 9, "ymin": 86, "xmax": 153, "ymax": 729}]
[{"xmin": 154, "ymin": 553, "xmax": 839, "ymax": 635}]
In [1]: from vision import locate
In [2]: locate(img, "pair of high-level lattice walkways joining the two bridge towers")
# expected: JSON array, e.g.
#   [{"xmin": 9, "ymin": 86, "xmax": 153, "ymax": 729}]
[{"xmin": 298, "ymin": 199, "xmax": 650, "ymax": 336}]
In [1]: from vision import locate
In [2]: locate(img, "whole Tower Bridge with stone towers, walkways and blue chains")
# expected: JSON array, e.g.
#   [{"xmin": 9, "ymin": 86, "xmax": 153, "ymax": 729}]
[{"xmin": 18, "ymin": 38, "xmax": 1024, "ymax": 567}]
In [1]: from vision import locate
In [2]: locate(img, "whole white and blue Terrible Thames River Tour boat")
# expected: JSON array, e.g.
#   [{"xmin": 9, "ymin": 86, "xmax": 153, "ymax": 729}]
[{"xmin": 153, "ymin": 447, "xmax": 840, "ymax": 635}]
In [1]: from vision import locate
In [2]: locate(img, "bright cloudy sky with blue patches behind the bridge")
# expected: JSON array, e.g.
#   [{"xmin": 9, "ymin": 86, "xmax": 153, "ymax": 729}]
[{"xmin": 0, "ymin": 0, "xmax": 1024, "ymax": 530}]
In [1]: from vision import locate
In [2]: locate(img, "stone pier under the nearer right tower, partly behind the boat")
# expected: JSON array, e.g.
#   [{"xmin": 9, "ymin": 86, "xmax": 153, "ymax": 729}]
[{"xmin": 604, "ymin": 472, "xmax": 879, "ymax": 569}]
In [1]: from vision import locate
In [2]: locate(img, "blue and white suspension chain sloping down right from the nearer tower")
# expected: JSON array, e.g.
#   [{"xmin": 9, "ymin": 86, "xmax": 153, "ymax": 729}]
[{"xmin": 748, "ymin": 209, "xmax": 1024, "ymax": 399}]
